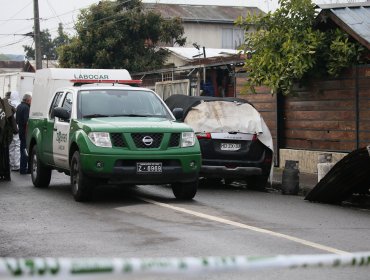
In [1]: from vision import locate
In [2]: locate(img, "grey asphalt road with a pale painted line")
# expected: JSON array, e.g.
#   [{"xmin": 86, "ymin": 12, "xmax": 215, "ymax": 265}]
[{"xmin": 0, "ymin": 172, "xmax": 370, "ymax": 279}]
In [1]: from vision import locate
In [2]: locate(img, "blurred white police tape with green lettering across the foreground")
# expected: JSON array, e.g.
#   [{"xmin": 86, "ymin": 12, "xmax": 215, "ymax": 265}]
[{"xmin": 0, "ymin": 252, "xmax": 370, "ymax": 279}]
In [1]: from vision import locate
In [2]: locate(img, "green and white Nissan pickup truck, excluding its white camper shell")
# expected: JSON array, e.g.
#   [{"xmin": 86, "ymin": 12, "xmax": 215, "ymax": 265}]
[{"xmin": 27, "ymin": 74, "xmax": 201, "ymax": 201}]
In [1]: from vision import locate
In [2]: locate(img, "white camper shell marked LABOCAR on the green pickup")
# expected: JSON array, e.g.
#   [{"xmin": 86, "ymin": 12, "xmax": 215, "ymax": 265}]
[{"xmin": 30, "ymin": 68, "xmax": 141, "ymax": 118}]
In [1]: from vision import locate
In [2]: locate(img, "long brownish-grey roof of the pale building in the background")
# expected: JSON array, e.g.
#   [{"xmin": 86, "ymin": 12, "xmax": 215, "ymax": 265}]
[{"xmin": 143, "ymin": 3, "xmax": 263, "ymax": 23}]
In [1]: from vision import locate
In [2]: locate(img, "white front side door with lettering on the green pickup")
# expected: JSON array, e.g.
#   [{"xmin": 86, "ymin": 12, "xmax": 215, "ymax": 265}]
[{"xmin": 53, "ymin": 92, "xmax": 73, "ymax": 169}]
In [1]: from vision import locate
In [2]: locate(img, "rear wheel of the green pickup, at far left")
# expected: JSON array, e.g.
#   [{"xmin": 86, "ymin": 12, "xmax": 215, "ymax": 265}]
[{"xmin": 30, "ymin": 145, "xmax": 51, "ymax": 188}]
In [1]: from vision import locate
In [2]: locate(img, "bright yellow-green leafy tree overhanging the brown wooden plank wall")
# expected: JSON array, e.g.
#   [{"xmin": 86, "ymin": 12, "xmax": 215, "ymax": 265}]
[{"xmin": 237, "ymin": 0, "xmax": 363, "ymax": 94}]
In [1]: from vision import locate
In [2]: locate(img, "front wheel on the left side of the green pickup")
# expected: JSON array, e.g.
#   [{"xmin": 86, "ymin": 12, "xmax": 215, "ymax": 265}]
[{"xmin": 71, "ymin": 151, "xmax": 92, "ymax": 202}]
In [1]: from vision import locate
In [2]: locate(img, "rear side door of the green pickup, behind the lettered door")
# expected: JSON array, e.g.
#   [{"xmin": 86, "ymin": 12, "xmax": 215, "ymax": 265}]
[{"xmin": 41, "ymin": 92, "xmax": 64, "ymax": 165}]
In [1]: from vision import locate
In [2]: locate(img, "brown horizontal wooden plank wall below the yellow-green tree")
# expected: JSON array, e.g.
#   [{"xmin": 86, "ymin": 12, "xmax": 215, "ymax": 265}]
[{"xmin": 236, "ymin": 65, "xmax": 370, "ymax": 155}]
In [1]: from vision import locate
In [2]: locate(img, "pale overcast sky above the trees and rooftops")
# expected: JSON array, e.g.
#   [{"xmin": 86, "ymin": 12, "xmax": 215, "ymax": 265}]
[{"xmin": 0, "ymin": 0, "xmax": 364, "ymax": 54}]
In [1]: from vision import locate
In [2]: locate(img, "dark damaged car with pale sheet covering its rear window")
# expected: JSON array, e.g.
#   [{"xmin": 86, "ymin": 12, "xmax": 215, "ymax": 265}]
[{"xmin": 165, "ymin": 95, "xmax": 273, "ymax": 190}]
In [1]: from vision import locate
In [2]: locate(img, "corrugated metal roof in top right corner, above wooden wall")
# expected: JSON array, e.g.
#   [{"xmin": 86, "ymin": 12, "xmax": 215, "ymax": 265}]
[{"xmin": 318, "ymin": 2, "xmax": 370, "ymax": 49}]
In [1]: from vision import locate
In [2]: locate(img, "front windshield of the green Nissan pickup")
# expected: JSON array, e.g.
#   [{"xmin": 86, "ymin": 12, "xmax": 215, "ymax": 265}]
[{"xmin": 77, "ymin": 89, "xmax": 172, "ymax": 119}]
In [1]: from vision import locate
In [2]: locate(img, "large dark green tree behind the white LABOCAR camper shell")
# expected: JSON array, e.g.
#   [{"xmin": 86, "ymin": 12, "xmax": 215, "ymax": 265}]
[{"xmin": 59, "ymin": 0, "xmax": 185, "ymax": 72}]
